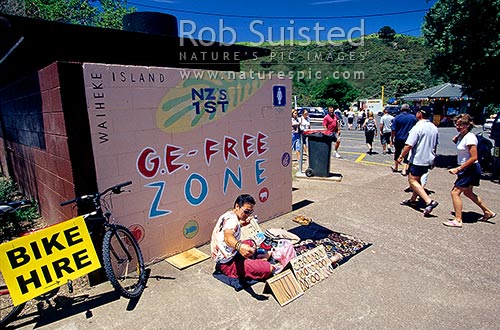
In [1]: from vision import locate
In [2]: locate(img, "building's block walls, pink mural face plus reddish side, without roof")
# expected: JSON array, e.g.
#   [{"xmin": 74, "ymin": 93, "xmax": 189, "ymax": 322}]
[{"xmin": 0, "ymin": 62, "xmax": 291, "ymax": 261}]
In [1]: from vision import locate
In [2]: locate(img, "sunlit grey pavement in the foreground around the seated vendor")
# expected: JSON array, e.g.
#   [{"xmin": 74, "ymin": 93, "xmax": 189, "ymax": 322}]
[{"xmin": 9, "ymin": 159, "xmax": 500, "ymax": 330}]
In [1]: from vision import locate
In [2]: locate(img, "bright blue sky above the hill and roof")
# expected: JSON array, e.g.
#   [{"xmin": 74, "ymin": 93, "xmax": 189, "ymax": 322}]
[{"xmin": 128, "ymin": 0, "xmax": 437, "ymax": 43}]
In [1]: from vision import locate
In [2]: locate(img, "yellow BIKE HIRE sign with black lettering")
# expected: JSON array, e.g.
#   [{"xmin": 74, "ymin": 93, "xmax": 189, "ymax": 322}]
[{"xmin": 0, "ymin": 216, "xmax": 101, "ymax": 305}]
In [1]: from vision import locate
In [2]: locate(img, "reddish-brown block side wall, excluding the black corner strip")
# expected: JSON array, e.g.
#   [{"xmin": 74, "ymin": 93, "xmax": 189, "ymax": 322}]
[{"xmin": 0, "ymin": 63, "xmax": 89, "ymax": 224}]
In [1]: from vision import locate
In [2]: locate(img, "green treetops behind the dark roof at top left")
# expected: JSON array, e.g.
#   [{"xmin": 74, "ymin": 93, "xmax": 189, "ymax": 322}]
[{"xmin": 0, "ymin": 0, "xmax": 136, "ymax": 29}]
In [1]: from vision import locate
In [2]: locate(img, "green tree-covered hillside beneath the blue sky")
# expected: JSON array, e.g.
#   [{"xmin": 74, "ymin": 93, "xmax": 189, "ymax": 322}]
[{"xmin": 243, "ymin": 34, "xmax": 442, "ymax": 106}]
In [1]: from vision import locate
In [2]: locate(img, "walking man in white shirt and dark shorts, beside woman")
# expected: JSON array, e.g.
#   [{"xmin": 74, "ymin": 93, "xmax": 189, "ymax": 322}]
[{"xmin": 398, "ymin": 108, "xmax": 438, "ymax": 216}]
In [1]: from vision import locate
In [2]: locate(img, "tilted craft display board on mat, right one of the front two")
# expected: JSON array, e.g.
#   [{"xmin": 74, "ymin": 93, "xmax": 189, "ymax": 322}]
[{"xmin": 290, "ymin": 245, "xmax": 333, "ymax": 291}]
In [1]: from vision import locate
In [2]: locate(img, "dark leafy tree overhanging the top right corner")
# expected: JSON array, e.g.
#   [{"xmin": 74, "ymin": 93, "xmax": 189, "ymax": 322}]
[{"xmin": 422, "ymin": 0, "xmax": 500, "ymax": 104}]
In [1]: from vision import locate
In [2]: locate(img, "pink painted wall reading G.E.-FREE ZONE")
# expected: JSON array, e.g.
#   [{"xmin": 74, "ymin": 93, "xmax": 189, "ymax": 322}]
[{"xmin": 83, "ymin": 63, "xmax": 292, "ymax": 260}]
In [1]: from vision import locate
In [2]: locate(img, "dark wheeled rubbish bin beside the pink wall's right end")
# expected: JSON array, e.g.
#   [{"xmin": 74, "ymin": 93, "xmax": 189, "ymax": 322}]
[{"xmin": 304, "ymin": 131, "xmax": 334, "ymax": 177}]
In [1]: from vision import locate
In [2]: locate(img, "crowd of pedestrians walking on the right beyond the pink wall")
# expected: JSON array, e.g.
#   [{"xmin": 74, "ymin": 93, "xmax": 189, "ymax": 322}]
[{"xmin": 292, "ymin": 104, "xmax": 497, "ymax": 228}]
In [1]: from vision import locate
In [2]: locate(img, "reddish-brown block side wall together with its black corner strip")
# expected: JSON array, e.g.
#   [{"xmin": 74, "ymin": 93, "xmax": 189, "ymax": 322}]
[{"xmin": 0, "ymin": 63, "xmax": 95, "ymax": 224}]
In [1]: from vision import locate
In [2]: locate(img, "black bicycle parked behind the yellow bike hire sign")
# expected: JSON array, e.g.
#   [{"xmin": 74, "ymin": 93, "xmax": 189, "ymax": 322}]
[{"xmin": 0, "ymin": 181, "xmax": 147, "ymax": 327}]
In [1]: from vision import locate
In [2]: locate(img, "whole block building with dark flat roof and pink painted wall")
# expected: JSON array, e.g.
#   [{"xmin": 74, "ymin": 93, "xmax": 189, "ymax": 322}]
[{"xmin": 0, "ymin": 13, "xmax": 292, "ymax": 261}]
